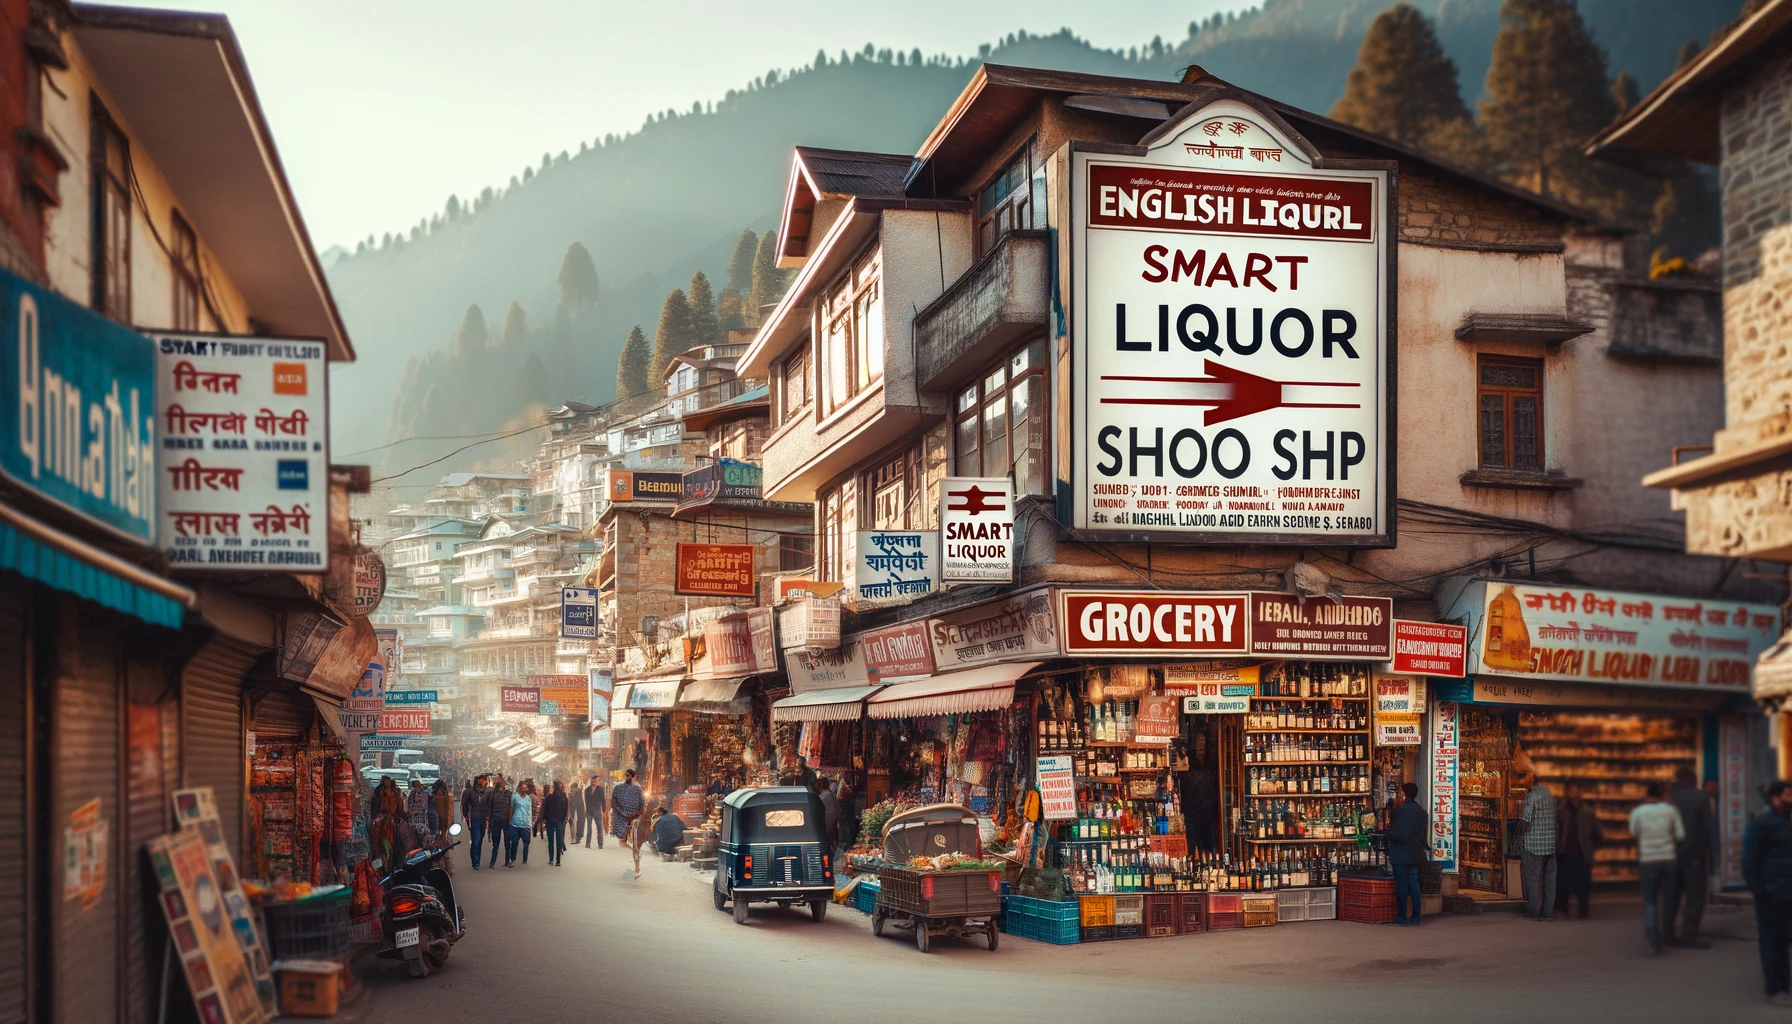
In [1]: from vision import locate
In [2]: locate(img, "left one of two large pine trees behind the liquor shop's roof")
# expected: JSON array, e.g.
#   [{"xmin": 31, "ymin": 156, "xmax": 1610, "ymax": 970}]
[{"xmin": 1331, "ymin": 4, "xmax": 1471, "ymax": 149}]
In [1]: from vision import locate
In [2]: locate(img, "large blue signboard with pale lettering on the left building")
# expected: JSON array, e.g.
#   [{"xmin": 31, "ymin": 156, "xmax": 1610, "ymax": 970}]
[{"xmin": 0, "ymin": 273, "xmax": 156, "ymax": 543}]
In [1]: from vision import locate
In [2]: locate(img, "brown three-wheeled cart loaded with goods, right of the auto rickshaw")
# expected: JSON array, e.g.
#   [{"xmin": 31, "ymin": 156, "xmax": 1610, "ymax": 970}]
[{"xmin": 871, "ymin": 803, "xmax": 1002, "ymax": 952}]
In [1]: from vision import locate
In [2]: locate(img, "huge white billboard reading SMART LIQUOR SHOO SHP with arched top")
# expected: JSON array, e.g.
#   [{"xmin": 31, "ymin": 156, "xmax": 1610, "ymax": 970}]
[{"xmin": 1070, "ymin": 99, "xmax": 1394, "ymax": 545}]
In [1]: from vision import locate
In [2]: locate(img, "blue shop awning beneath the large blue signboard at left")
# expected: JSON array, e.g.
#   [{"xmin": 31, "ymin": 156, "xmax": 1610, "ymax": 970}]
[{"xmin": 0, "ymin": 504, "xmax": 199, "ymax": 629}]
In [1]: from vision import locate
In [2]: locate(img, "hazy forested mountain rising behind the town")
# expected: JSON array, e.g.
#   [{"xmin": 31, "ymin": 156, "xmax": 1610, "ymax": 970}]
[{"xmin": 328, "ymin": 0, "xmax": 1740, "ymax": 481}]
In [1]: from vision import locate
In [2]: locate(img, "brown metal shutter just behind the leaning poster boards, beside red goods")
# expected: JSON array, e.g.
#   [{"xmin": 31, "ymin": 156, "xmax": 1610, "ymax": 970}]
[{"xmin": 181, "ymin": 635, "xmax": 263, "ymax": 864}]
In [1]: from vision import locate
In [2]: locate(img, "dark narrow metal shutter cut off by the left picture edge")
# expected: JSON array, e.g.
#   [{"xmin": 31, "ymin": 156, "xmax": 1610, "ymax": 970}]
[{"xmin": 0, "ymin": 577, "xmax": 32, "ymax": 1024}]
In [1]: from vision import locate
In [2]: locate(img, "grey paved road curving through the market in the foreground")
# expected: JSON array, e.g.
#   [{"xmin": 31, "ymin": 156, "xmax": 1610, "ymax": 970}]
[{"xmin": 326, "ymin": 843, "xmax": 1792, "ymax": 1024}]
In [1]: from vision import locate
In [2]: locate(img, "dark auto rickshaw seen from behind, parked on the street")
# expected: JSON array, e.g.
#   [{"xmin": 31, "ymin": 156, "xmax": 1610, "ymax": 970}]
[{"xmin": 715, "ymin": 785, "xmax": 833, "ymax": 924}]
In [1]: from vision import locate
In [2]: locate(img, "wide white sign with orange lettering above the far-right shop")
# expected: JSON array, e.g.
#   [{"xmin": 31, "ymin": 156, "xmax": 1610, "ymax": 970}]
[{"xmin": 1450, "ymin": 581, "xmax": 1779, "ymax": 694}]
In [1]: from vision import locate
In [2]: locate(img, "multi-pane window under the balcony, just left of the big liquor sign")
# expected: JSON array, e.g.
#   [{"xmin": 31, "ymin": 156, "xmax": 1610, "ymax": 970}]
[{"xmin": 953, "ymin": 341, "xmax": 1050, "ymax": 495}]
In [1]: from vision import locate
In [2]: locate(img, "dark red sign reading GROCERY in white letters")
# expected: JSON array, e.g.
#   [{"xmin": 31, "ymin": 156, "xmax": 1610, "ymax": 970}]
[{"xmin": 1057, "ymin": 590, "xmax": 1249, "ymax": 655}]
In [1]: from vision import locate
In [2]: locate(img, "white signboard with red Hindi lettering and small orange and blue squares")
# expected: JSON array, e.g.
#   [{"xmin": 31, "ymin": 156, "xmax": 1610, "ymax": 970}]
[{"xmin": 151, "ymin": 334, "xmax": 330, "ymax": 572}]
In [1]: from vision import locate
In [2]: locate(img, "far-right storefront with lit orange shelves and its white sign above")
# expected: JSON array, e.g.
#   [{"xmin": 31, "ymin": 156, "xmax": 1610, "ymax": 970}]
[{"xmin": 1426, "ymin": 581, "xmax": 1779, "ymax": 897}]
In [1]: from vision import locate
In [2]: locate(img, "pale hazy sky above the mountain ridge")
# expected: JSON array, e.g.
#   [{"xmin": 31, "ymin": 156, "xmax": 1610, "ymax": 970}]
[{"xmin": 131, "ymin": 0, "xmax": 1254, "ymax": 249}]
